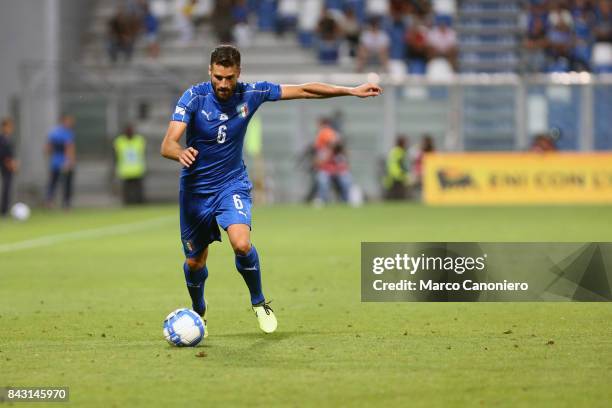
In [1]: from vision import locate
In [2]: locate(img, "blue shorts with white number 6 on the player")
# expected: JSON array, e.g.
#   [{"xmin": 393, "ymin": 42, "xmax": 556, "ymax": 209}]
[{"xmin": 179, "ymin": 180, "xmax": 252, "ymax": 258}]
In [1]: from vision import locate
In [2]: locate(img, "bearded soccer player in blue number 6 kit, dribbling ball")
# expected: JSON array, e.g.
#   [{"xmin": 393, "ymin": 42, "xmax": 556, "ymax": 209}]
[{"xmin": 161, "ymin": 45, "xmax": 382, "ymax": 333}]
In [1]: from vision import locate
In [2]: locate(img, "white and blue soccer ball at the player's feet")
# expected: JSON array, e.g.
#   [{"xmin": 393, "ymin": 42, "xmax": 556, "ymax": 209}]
[{"xmin": 164, "ymin": 309, "xmax": 206, "ymax": 347}]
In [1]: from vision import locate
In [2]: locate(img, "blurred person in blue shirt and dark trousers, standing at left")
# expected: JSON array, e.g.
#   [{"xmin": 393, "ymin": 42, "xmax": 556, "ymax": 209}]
[{"xmin": 46, "ymin": 114, "xmax": 76, "ymax": 209}]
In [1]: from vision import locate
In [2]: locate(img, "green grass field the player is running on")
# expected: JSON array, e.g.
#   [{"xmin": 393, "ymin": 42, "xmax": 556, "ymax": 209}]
[{"xmin": 0, "ymin": 205, "xmax": 612, "ymax": 407}]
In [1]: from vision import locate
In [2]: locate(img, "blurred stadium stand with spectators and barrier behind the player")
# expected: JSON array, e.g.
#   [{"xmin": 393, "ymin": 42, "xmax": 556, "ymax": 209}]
[{"xmin": 5, "ymin": 0, "xmax": 612, "ymax": 201}]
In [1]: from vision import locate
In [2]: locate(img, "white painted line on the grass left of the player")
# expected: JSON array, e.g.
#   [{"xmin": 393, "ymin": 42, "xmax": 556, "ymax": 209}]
[{"xmin": 0, "ymin": 216, "xmax": 176, "ymax": 254}]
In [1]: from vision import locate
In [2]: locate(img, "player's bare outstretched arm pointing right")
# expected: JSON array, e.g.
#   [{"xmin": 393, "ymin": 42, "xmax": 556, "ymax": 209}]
[{"xmin": 281, "ymin": 82, "xmax": 382, "ymax": 99}]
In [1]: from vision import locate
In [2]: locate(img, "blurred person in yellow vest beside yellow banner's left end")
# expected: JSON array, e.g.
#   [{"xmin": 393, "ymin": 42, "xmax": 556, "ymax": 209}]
[{"xmin": 383, "ymin": 135, "xmax": 409, "ymax": 200}]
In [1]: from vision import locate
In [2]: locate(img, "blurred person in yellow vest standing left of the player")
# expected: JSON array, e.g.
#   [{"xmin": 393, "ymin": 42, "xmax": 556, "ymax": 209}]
[{"xmin": 113, "ymin": 125, "xmax": 146, "ymax": 205}]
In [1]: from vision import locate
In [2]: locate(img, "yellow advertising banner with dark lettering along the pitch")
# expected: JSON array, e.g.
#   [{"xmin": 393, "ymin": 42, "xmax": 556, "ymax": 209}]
[{"xmin": 423, "ymin": 152, "xmax": 612, "ymax": 204}]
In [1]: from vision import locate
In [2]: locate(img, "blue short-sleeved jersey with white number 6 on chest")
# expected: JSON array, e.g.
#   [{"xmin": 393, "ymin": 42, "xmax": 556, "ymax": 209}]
[{"xmin": 172, "ymin": 82, "xmax": 281, "ymax": 194}]
